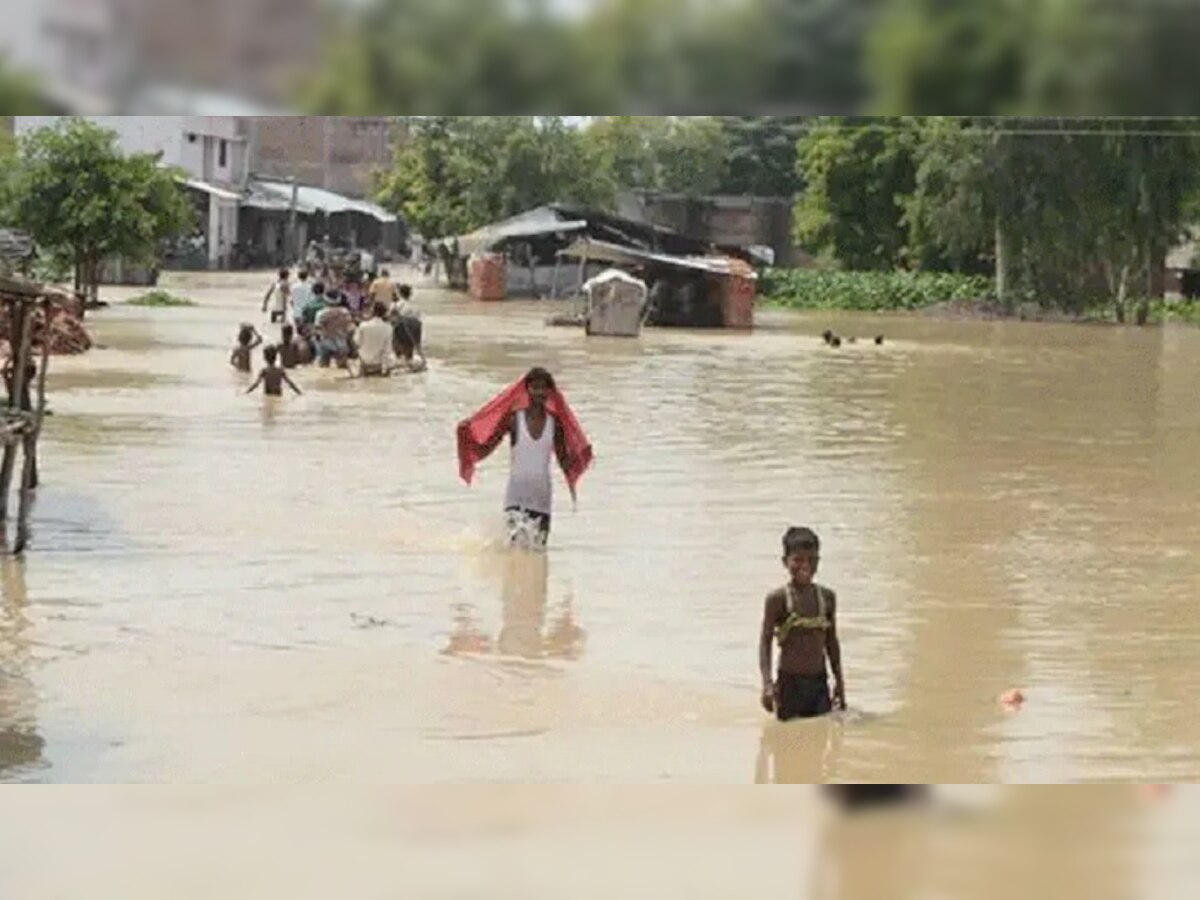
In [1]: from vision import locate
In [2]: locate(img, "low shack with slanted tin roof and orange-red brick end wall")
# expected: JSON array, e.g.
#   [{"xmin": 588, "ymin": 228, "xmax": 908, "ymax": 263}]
[{"xmin": 562, "ymin": 238, "xmax": 758, "ymax": 329}]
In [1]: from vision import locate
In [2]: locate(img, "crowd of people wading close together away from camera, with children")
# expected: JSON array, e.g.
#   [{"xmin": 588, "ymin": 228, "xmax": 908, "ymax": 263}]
[{"xmin": 229, "ymin": 269, "xmax": 426, "ymax": 396}]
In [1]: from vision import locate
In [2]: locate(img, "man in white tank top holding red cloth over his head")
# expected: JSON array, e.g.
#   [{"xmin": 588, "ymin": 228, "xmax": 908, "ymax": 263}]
[{"xmin": 458, "ymin": 368, "xmax": 593, "ymax": 547}]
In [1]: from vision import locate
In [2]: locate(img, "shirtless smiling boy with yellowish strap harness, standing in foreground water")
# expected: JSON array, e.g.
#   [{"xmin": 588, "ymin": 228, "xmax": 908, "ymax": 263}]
[{"xmin": 758, "ymin": 528, "xmax": 846, "ymax": 722}]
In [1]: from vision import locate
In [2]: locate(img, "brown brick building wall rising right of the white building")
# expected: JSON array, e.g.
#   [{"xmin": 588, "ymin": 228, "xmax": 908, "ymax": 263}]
[{"xmin": 247, "ymin": 115, "xmax": 398, "ymax": 197}]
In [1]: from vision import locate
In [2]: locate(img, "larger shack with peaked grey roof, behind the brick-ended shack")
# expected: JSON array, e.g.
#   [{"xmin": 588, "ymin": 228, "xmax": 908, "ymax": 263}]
[{"xmin": 438, "ymin": 204, "xmax": 750, "ymax": 299}]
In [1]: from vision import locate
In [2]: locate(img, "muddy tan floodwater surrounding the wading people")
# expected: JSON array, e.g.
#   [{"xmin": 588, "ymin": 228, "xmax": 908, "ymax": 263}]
[{"xmin": 0, "ymin": 275, "xmax": 1200, "ymax": 896}]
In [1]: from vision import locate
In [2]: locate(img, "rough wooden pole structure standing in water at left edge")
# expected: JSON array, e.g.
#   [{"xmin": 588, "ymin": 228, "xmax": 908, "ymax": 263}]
[{"xmin": 0, "ymin": 278, "xmax": 50, "ymax": 554}]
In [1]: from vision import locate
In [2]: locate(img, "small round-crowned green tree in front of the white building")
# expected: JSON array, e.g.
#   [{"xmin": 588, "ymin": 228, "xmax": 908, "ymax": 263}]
[{"xmin": 12, "ymin": 119, "xmax": 192, "ymax": 298}]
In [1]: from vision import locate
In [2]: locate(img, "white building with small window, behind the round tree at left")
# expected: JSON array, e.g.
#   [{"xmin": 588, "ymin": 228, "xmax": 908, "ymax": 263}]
[{"xmin": 16, "ymin": 115, "xmax": 250, "ymax": 266}]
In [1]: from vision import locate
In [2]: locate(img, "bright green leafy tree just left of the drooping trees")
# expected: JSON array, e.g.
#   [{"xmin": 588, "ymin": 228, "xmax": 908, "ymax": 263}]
[{"xmin": 796, "ymin": 118, "xmax": 918, "ymax": 269}]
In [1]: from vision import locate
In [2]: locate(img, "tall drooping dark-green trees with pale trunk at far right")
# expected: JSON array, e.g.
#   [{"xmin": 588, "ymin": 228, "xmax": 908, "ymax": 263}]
[{"xmin": 907, "ymin": 119, "xmax": 1200, "ymax": 320}]
